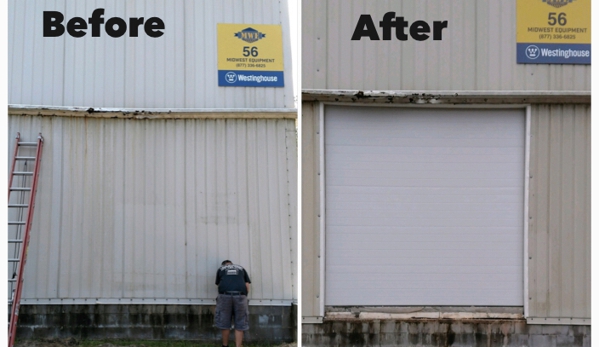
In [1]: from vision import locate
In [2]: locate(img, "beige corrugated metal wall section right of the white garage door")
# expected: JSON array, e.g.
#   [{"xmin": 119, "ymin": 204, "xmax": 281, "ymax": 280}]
[{"xmin": 528, "ymin": 105, "xmax": 591, "ymax": 324}]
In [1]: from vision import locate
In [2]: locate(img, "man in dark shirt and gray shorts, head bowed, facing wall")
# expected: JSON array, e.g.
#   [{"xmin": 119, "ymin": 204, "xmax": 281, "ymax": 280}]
[{"xmin": 214, "ymin": 260, "xmax": 251, "ymax": 347}]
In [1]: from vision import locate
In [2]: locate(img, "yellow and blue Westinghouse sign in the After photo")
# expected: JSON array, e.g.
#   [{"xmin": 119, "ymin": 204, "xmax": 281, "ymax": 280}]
[{"xmin": 516, "ymin": 0, "xmax": 591, "ymax": 64}]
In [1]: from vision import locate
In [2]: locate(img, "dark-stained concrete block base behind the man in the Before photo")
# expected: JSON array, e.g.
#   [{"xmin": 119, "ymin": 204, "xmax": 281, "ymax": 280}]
[{"xmin": 17, "ymin": 305, "xmax": 297, "ymax": 343}]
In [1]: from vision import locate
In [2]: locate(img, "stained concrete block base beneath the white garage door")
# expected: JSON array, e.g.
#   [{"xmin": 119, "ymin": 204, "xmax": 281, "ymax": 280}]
[{"xmin": 302, "ymin": 318, "xmax": 591, "ymax": 347}]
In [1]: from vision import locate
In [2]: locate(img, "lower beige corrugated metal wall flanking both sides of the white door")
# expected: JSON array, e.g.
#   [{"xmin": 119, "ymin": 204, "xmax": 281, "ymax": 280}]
[{"xmin": 301, "ymin": 102, "xmax": 591, "ymax": 324}]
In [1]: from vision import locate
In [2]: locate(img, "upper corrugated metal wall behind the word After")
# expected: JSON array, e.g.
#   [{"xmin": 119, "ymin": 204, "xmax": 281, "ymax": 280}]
[{"xmin": 302, "ymin": 0, "xmax": 591, "ymax": 91}]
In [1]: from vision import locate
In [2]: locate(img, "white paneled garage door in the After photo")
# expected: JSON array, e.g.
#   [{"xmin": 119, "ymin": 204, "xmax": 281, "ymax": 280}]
[{"xmin": 324, "ymin": 106, "xmax": 526, "ymax": 306}]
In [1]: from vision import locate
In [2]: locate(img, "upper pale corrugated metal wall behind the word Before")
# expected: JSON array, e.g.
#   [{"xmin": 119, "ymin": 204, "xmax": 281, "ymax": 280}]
[{"xmin": 8, "ymin": 0, "xmax": 294, "ymax": 108}]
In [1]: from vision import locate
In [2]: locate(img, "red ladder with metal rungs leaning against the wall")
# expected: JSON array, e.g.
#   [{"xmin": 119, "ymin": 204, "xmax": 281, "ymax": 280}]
[{"xmin": 8, "ymin": 133, "xmax": 44, "ymax": 347}]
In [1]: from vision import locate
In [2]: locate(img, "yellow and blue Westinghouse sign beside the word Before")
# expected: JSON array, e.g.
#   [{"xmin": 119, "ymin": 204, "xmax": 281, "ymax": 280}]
[{"xmin": 217, "ymin": 24, "xmax": 284, "ymax": 87}]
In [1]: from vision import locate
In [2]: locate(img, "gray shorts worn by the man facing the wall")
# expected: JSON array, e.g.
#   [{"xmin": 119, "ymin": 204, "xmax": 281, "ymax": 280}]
[{"xmin": 214, "ymin": 294, "xmax": 250, "ymax": 330}]
